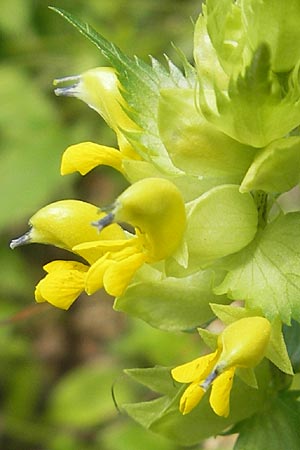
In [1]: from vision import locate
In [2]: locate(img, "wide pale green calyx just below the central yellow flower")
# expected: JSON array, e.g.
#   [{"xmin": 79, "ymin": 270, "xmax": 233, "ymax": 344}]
[{"xmin": 114, "ymin": 267, "xmax": 227, "ymax": 331}]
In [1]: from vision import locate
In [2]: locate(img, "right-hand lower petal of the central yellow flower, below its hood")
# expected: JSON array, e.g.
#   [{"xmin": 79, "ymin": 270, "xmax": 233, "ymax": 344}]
[{"xmin": 103, "ymin": 253, "xmax": 145, "ymax": 297}]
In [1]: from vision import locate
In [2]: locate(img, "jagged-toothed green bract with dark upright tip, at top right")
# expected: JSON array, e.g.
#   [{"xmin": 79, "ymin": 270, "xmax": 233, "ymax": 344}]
[{"xmin": 199, "ymin": 43, "xmax": 300, "ymax": 147}]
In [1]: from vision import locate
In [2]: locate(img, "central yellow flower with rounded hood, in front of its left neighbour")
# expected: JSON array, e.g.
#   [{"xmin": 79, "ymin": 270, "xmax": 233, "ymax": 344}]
[{"xmin": 73, "ymin": 178, "xmax": 186, "ymax": 297}]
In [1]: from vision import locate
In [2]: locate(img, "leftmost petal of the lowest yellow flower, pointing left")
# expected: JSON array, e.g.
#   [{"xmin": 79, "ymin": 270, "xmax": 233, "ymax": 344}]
[{"xmin": 171, "ymin": 349, "xmax": 219, "ymax": 383}]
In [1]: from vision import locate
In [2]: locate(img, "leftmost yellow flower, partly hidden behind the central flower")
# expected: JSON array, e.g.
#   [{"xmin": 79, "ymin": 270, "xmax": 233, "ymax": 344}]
[{"xmin": 10, "ymin": 200, "xmax": 125, "ymax": 309}]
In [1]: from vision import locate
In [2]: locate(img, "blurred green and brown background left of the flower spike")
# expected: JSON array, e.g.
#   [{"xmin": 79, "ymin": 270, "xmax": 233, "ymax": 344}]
[{"xmin": 0, "ymin": 0, "xmax": 234, "ymax": 450}]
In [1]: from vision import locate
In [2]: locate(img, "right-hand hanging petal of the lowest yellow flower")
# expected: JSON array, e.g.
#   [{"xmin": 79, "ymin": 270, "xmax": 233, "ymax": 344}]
[{"xmin": 209, "ymin": 367, "xmax": 235, "ymax": 417}]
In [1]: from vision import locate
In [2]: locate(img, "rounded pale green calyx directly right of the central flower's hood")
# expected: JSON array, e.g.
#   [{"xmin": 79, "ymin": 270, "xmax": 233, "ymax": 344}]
[{"xmin": 186, "ymin": 185, "xmax": 257, "ymax": 266}]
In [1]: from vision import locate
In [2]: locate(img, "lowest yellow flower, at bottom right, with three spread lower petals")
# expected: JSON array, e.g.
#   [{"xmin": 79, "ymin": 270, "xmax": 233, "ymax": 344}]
[{"xmin": 171, "ymin": 317, "xmax": 271, "ymax": 417}]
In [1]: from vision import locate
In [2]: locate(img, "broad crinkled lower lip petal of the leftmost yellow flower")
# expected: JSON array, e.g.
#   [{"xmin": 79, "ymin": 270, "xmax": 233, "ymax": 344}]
[{"xmin": 35, "ymin": 270, "xmax": 85, "ymax": 309}]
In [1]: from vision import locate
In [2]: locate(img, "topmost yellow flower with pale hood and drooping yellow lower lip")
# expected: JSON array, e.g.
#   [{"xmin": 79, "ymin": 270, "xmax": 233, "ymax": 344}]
[{"xmin": 54, "ymin": 67, "xmax": 140, "ymax": 179}]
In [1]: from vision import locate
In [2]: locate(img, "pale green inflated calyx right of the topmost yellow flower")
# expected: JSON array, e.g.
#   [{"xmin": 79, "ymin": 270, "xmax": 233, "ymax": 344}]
[{"xmin": 158, "ymin": 89, "xmax": 255, "ymax": 180}]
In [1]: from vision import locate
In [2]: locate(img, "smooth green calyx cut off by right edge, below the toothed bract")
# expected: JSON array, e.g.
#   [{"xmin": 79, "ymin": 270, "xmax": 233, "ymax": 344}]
[{"xmin": 240, "ymin": 136, "xmax": 300, "ymax": 192}]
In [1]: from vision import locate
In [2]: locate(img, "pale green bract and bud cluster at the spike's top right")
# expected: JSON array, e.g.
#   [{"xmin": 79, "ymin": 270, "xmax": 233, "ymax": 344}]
[{"xmin": 194, "ymin": 0, "xmax": 300, "ymax": 147}]
